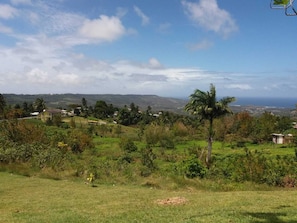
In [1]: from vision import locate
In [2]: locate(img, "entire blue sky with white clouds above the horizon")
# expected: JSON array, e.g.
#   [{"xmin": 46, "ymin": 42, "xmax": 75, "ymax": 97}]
[{"xmin": 0, "ymin": 0, "xmax": 297, "ymax": 98}]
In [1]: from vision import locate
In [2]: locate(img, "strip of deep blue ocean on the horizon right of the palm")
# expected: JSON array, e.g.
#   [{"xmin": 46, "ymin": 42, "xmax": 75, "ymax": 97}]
[{"xmin": 230, "ymin": 97, "xmax": 297, "ymax": 109}]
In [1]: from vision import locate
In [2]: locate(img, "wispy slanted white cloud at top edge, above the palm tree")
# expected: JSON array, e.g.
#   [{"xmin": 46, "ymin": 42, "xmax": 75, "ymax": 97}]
[{"xmin": 182, "ymin": 0, "xmax": 237, "ymax": 37}]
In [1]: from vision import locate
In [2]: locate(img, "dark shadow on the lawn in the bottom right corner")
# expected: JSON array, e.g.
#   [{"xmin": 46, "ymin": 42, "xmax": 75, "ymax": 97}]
[{"xmin": 244, "ymin": 212, "xmax": 297, "ymax": 223}]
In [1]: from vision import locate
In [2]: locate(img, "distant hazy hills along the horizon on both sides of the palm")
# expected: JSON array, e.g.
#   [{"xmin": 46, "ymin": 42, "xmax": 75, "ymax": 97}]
[{"xmin": 3, "ymin": 94, "xmax": 295, "ymax": 116}]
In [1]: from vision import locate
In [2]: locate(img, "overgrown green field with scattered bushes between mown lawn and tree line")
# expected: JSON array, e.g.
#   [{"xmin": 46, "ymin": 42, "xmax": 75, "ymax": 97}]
[{"xmin": 0, "ymin": 117, "xmax": 297, "ymax": 188}]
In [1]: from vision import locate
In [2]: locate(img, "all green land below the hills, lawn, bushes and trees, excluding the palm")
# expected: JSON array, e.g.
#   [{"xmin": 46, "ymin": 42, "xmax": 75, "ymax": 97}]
[{"xmin": 0, "ymin": 92, "xmax": 297, "ymax": 222}]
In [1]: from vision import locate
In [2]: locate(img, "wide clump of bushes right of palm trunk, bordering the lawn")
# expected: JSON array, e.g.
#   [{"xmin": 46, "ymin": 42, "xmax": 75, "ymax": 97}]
[{"xmin": 207, "ymin": 149, "xmax": 297, "ymax": 187}]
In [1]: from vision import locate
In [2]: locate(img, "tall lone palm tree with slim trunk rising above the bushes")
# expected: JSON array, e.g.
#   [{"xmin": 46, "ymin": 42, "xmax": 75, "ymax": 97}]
[{"xmin": 185, "ymin": 84, "xmax": 235, "ymax": 166}]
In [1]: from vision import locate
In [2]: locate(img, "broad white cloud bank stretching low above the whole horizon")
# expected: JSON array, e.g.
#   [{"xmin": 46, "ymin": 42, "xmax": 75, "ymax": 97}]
[{"xmin": 0, "ymin": 36, "xmax": 296, "ymax": 97}]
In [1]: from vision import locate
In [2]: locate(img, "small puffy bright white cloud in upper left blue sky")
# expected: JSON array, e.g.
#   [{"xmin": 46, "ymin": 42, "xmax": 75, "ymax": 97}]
[{"xmin": 79, "ymin": 15, "xmax": 126, "ymax": 42}]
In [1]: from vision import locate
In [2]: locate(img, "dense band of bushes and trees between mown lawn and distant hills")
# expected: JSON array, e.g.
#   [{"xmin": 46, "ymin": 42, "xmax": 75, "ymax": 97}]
[{"xmin": 0, "ymin": 94, "xmax": 297, "ymax": 187}]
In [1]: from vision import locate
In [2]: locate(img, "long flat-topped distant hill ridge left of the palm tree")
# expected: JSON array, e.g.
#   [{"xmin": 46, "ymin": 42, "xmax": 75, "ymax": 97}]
[{"xmin": 4, "ymin": 94, "xmax": 187, "ymax": 113}]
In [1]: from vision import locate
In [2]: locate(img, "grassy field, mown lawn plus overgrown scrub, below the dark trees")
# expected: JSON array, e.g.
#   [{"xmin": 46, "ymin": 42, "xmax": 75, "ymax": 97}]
[{"xmin": 0, "ymin": 117, "xmax": 297, "ymax": 223}]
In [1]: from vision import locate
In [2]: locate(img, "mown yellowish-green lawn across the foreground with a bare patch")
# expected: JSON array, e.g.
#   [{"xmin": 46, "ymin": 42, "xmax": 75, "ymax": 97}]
[{"xmin": 0, "ymin": 172, "xmax": 297, "ymax": 223}]
